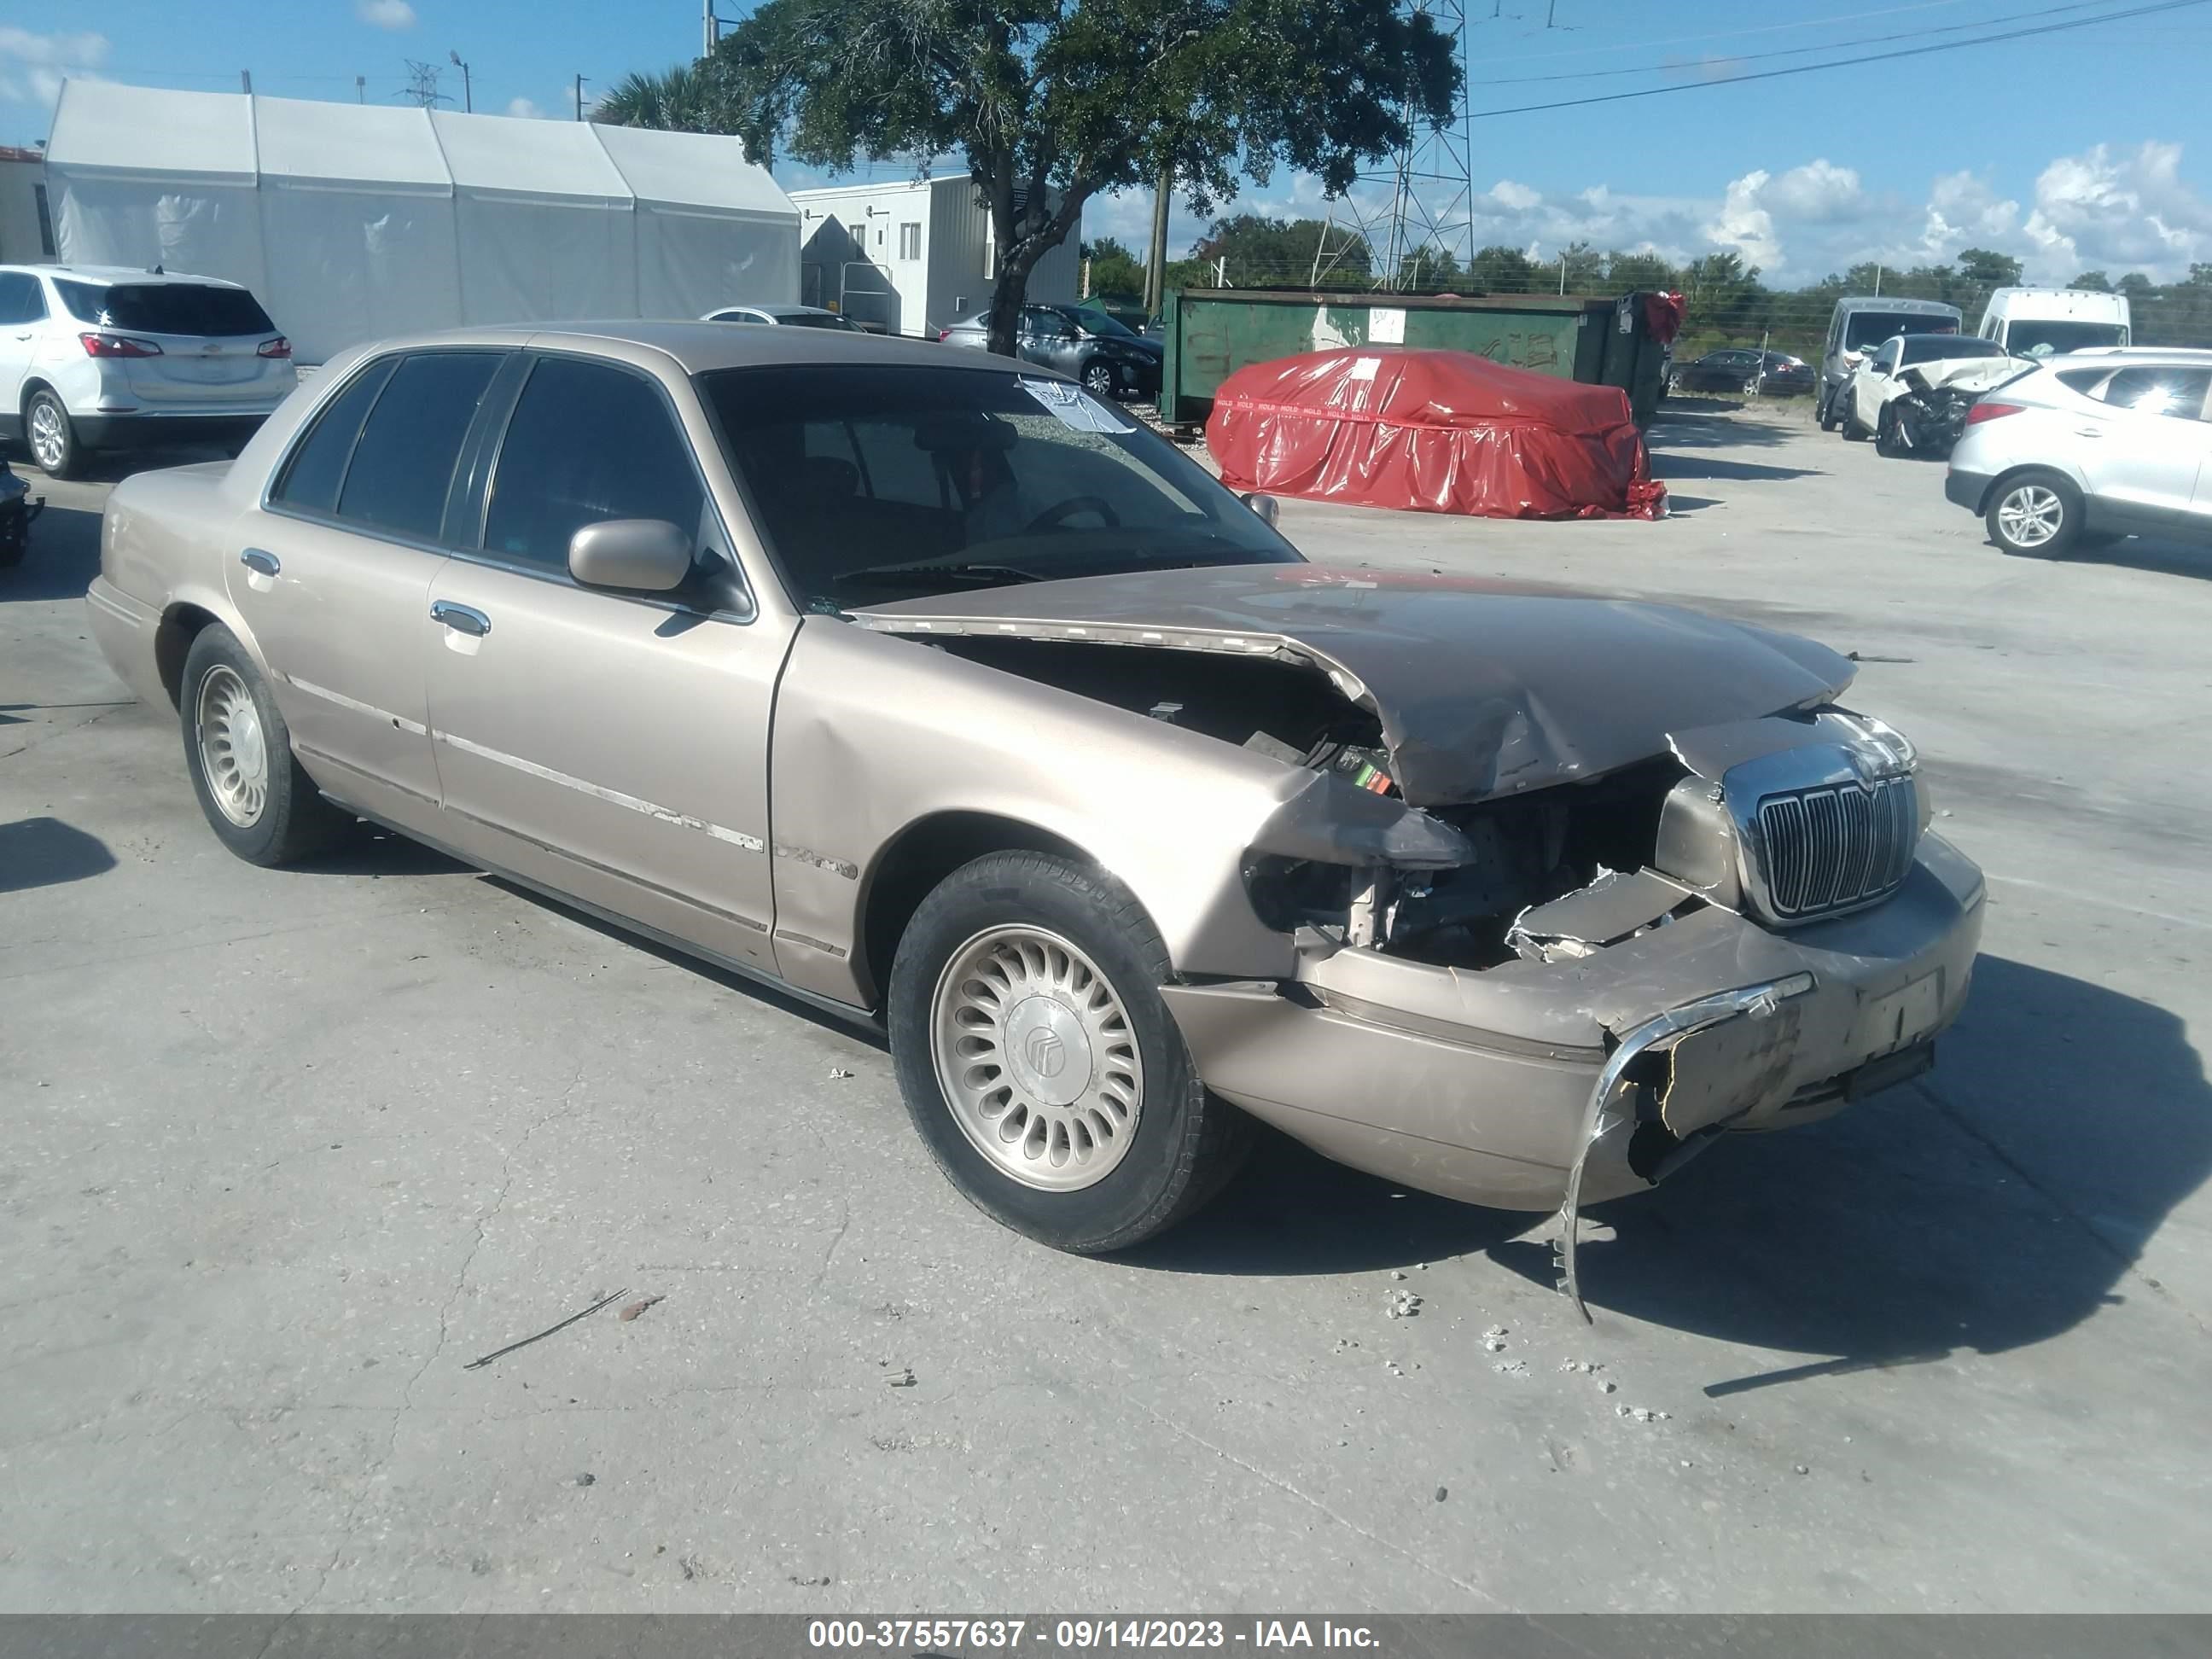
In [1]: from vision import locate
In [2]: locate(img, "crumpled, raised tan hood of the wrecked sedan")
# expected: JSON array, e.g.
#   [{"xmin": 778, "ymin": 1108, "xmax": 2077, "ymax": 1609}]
[{"xmin": 854, "ymin": 564, "xmax": 1856, "ymax": 807}]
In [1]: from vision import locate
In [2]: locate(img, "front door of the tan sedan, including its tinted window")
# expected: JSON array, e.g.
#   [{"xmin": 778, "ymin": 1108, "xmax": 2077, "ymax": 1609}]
[{"xmin": 418, "ymin": 352, "xmax": 789, "ymax": 967}]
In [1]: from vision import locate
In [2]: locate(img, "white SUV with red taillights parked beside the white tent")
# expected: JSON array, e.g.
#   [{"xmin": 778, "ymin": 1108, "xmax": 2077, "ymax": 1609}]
[{"xmin": 0, "ymin": 265, "xmax": 299, "ymax": 478}]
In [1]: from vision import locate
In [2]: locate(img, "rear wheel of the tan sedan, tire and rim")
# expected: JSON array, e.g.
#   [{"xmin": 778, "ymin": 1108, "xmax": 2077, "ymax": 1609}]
[{"xmin": 177, "ymin": 624, "xmax": 352, "ymax": 864}]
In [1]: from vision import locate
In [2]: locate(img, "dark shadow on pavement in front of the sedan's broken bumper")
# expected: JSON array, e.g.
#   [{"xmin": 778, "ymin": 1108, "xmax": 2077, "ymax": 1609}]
[{"xmin": 1491, "ymin": 956, "xmax": 2212, "ymax": 1396}]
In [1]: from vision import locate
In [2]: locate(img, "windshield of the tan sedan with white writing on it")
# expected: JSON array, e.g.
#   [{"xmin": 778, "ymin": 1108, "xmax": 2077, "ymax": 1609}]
[{"xmin": 699, "ymin": 363, "xmax": 1301, "ymax": 610}]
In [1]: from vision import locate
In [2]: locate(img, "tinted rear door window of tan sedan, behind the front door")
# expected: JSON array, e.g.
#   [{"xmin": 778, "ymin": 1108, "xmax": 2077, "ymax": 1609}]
[{"xmin": 339, "ymin": 352, "xmax": 502, "ymax": 539}]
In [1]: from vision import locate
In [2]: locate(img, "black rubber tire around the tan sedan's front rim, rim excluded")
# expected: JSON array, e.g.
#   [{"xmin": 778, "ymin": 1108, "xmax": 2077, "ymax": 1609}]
[{"xmin": 889, "ymin": 852, "xmax": 1252, "ymax": 1254}]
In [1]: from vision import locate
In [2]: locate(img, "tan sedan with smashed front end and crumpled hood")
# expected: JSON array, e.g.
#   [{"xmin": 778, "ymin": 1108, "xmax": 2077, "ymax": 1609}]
[{"xmin": 89, "ymin": 323, "xmax": 1982, "ymax": 1309}]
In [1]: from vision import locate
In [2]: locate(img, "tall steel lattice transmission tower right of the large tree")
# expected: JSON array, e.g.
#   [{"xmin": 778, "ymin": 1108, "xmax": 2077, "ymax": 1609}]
[{"xmin": 1312, "ymin": 0, "xmax": 1476, "ymax": 290}]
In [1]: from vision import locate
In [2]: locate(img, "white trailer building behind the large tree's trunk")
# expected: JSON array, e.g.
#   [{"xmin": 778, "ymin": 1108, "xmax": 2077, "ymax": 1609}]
[{"xmin": 792, "ymin": 175, "xmax": 1081, "ymax": 339}]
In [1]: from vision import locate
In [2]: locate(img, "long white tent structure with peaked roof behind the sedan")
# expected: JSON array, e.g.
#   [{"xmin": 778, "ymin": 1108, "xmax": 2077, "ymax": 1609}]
[{"xmin": 46, "ymin": 79, "xmax": 799, "ymax": 363}]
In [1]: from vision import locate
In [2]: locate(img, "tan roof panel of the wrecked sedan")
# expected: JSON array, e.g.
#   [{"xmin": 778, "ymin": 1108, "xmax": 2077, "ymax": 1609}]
[{"xmin": 329, "ymin": 320, "xmax": 1062, "ymax": 378}]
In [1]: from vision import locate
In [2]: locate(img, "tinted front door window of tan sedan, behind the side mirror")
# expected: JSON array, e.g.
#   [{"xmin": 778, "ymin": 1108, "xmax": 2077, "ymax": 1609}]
[{"xmin": 485, "ymin": 356, "xmax": 707, "ymax": 571}]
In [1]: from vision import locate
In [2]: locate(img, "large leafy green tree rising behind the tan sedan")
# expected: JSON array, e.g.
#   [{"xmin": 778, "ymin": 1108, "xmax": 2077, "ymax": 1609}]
[{"xmin": 713, "ymin": 0, "xmax": 1460, "ymax": 356}]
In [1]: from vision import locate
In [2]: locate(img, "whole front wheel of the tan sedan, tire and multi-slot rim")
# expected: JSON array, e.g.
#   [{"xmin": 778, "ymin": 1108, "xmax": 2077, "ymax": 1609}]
[{"xmin": 889, "ymin": 852, "xmax": 1249, "ymax": 1254}]
